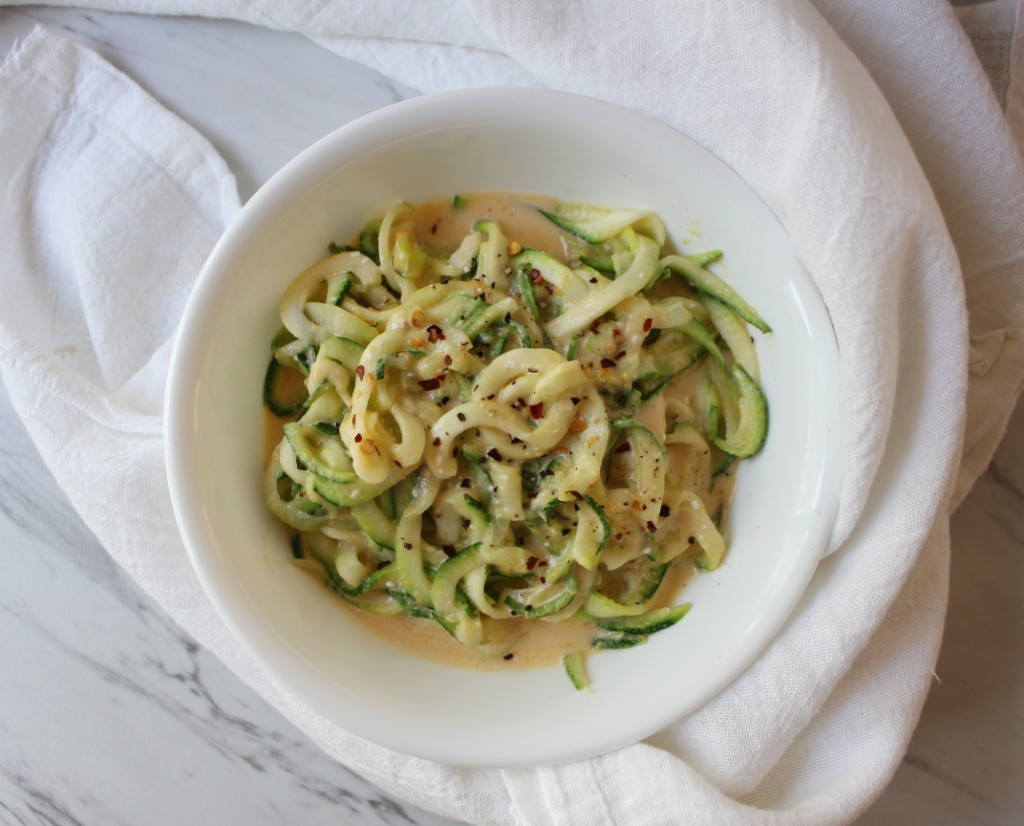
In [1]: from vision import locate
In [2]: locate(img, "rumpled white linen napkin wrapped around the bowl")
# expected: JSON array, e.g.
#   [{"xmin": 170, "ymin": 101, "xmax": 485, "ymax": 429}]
[{"xmin": 0, "ymin": 0, "xmax": 1024, "ymax": 824}]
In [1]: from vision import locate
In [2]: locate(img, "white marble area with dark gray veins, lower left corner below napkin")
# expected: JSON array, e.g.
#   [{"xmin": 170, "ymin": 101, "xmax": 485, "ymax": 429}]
[{"xmin": 0, "ymin": 376, "xmax": 460, "ymax": 826}]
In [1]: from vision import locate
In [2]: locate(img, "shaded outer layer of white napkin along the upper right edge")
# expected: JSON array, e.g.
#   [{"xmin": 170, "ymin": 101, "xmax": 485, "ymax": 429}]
[{"xmin": 815, "ymin": 0, "xmax": 1024, "ymax": 505}]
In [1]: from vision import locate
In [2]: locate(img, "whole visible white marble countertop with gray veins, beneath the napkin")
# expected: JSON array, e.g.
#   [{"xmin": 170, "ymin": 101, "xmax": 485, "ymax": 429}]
[{"xmin": 0, "ymin": 8, "xmax": 1024, "ymax": 826}]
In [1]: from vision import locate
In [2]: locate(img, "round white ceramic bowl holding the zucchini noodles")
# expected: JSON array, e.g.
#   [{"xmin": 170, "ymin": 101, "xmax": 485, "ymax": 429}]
[{"xmin": 166, "ymin": 89, "xmax": 840, "ymax": 767}]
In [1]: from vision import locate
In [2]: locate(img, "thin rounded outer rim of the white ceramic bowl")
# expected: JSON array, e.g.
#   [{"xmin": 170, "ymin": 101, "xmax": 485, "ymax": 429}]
[{"xmin": 164, "ymin": 87, "xmax": 842, "ymax": 767}]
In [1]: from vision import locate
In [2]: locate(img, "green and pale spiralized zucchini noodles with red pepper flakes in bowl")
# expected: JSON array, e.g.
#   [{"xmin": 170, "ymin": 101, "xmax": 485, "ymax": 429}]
[{"xmin": 264, "ymin": 197, "xmax": 769, "ymax": 684}]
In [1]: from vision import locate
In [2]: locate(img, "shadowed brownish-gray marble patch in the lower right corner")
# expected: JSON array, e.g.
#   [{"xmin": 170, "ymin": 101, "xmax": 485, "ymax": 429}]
[{"xmin": 863, "ymin": 390, "xmax": 1024, "ymax": 826}]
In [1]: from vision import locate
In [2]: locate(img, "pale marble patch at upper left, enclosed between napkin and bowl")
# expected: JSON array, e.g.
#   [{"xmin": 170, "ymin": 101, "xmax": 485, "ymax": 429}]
[{"xmin": 0, "ymin": 7, "xmax": 417, "ymax": 201}]
